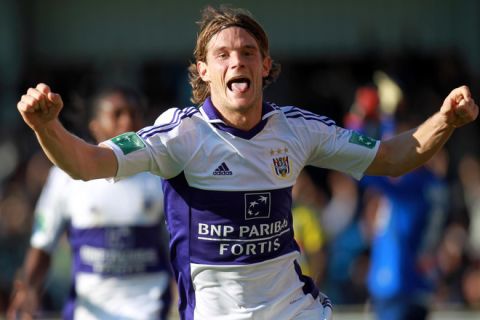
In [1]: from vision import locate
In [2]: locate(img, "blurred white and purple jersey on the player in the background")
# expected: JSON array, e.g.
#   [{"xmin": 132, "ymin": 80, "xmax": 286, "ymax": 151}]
[{"xmin": 31, "ymin": 167, "xmax": 171, "ymax": 320}]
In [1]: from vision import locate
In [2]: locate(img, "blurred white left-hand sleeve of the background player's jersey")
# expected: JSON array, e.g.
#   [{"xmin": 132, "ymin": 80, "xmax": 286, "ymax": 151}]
[{"xmin": 30, "ymin": 167, "xmax": 72, "ymax": 253}]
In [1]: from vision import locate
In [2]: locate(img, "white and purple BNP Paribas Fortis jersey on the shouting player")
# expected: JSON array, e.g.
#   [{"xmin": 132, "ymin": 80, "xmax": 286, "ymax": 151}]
[{"xmin": 104, "ymin": 99, "xmax": 378, "ymax": 320}]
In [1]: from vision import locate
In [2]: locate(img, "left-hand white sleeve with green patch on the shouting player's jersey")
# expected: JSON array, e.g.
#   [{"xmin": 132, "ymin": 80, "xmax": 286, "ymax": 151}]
[{"xmin": 101, "ymin": 108, "xmax": 191, "ymax": 180}]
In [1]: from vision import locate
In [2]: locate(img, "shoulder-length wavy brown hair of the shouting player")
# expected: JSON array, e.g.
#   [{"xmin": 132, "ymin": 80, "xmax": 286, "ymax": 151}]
[{"xmin": 188, "ymin": 6, "xmax": 280, "ymax": 104}]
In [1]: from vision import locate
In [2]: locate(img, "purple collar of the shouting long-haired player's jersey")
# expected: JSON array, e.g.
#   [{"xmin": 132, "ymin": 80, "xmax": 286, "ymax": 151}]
[{"xmin": 200, "ymin": 97, "xmax": 278, "ymax": 140}]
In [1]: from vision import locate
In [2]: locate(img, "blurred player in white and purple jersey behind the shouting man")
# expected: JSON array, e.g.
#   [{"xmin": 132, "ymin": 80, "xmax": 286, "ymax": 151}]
[{"xmin": 8, "ymin": 87, "xmax": 171, "ymax": 319}]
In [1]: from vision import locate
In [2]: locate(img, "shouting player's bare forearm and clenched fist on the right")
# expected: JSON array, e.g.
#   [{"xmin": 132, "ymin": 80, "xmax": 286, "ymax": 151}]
[{"xmin": 365, "ymin": 86, "xmax": 478, "ymax": 177}]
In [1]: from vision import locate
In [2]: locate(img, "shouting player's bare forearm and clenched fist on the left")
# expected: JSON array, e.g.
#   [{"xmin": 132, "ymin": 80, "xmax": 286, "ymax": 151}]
[{"xmin": 17, "ymin": 83, "xmax": 118, "ymax": 180}]
